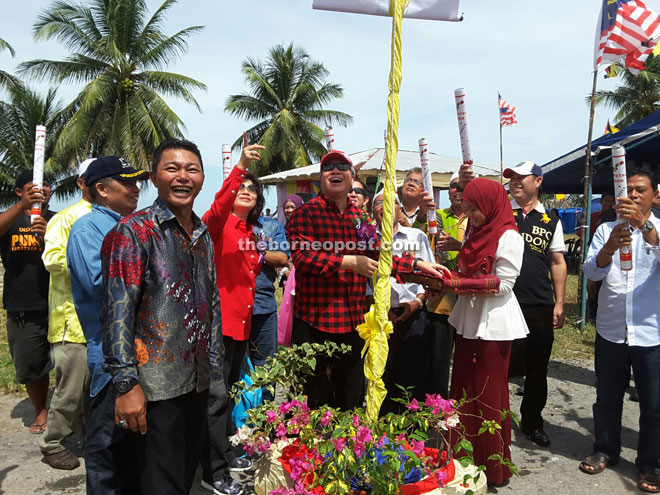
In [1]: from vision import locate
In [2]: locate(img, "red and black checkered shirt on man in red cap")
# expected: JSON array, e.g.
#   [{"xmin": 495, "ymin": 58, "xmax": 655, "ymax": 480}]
[{"xmin": 287, "ymin": 193, "xmax": 413, "ymax": 333}]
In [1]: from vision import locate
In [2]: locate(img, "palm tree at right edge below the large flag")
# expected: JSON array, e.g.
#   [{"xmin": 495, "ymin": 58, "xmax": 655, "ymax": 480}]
[{"xmin": 587, "ymin": 55, "xmax": 660, "ymax": 129}]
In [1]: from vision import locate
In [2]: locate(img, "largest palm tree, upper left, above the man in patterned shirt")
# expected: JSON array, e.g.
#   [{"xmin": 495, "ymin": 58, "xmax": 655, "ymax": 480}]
[{"xmin": 20, "ymin": 0, "xmax": 206, "ymax": 168}]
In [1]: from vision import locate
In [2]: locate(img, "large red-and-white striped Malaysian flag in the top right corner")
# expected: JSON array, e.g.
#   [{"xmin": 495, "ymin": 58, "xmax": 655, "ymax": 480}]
[{"xmin": 594, "ymin": 0, "xmax": 660, "ymax": 73}]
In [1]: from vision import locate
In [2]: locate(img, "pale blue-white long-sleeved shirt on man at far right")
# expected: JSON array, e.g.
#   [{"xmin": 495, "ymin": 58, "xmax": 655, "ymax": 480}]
[{"xmin": 584, "ymin": 214, "xmax": 660, "ymax": 347}]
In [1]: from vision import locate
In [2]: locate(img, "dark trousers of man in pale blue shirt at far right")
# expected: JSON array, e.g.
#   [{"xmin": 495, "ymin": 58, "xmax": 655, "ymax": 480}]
[{"xmin": 593, "ymin": 334, "xmax": 660, "ymax": 473}]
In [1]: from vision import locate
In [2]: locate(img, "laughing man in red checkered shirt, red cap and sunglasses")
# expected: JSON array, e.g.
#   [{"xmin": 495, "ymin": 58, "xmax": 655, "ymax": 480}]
[{"xmin": 287, "ymin": 151, "xmax": 442, "ymax": 409}]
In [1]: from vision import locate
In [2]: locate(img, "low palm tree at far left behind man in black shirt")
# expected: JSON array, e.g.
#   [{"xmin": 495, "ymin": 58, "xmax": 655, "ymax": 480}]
[{"xmin": 0, "ymin": 84, "xmax": 75, "ymax": 206}]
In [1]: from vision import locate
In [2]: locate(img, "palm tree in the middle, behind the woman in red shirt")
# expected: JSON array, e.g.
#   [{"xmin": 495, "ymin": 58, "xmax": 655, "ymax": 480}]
[{"xmin": 225, "ymin": 44, "xmax": 353, "ymax": 174}]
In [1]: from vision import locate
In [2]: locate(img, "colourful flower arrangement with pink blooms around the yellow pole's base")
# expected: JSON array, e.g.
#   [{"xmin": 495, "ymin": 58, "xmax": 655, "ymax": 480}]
[{"xmin": 231, "ymin": 343, "xmax": 515, "ymax": 495}]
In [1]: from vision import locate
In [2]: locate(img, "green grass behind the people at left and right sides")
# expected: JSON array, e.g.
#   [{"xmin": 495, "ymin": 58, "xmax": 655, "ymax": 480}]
[{"xmin": 0, "ymin": 275, "xmax": 596, "ymax": 391}]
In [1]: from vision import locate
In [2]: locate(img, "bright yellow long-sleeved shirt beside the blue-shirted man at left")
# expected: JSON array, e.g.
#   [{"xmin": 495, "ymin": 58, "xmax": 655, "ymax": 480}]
[{"xmin": 41, "ymin": 199, "xmax": 91, "ymax": 344}]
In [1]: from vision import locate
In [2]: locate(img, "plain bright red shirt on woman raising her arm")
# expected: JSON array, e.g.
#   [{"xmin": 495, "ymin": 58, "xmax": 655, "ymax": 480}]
[{"xmin": 202, "ymin": 167, "xmax": 261, "ymax": 340}]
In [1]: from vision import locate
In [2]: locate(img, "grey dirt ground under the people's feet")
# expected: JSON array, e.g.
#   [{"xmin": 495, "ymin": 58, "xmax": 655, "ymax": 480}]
[{"xmin": 0, "ymin": 361, "xmax": 640, "ymax": 495}]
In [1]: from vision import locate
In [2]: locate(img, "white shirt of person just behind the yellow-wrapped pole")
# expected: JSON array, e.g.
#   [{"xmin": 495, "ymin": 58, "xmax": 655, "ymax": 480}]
[{"xmin": 367, "ymin": 225, "xmax": 435, "ymax": 308}]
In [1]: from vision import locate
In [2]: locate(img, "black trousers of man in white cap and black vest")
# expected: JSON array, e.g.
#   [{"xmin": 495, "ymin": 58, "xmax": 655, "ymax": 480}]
[{"xmin": 520, "ymin": 304, "xmax": 555, "ymax": 433}]
